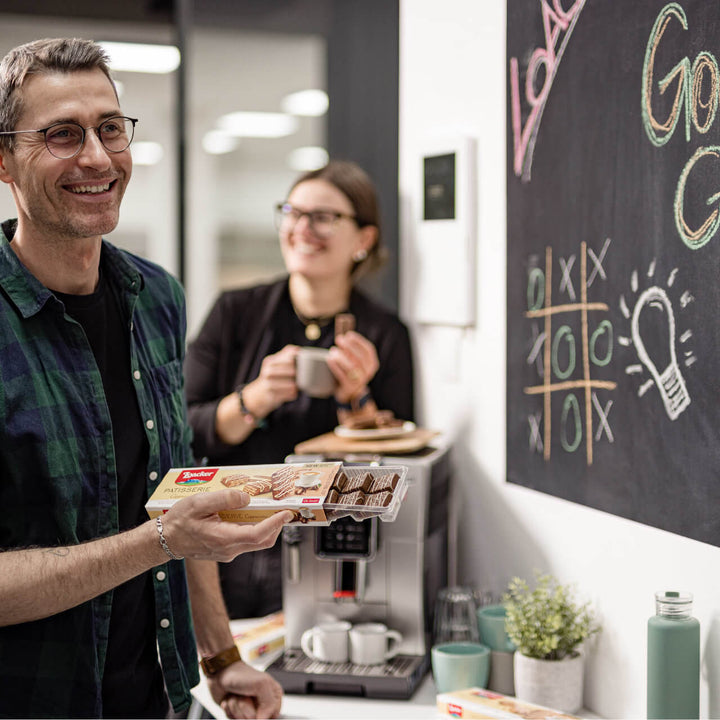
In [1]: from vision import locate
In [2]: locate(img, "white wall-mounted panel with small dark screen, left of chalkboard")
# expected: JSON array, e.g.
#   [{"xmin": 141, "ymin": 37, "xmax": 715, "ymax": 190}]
[{"xmin": 409, "ymin": 135, "xmax": 477, "ymax": 326}]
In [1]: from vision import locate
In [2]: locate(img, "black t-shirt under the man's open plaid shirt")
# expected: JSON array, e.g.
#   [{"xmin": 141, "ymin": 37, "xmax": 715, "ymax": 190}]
[{"xmin": 55, "ymin": 273, "xmax": 168, "ymax": 718}]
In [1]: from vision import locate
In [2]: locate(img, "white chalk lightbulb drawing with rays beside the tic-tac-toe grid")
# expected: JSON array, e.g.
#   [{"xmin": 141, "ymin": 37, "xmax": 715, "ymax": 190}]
[{"xmin": 619, "ymin": 260, "xmax": 696, "ymax": 420}]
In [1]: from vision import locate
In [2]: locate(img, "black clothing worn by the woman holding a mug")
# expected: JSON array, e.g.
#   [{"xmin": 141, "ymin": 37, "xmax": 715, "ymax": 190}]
[{"xmin": 185, "ymin": 278, "xmax": 415, "ymax": 618}]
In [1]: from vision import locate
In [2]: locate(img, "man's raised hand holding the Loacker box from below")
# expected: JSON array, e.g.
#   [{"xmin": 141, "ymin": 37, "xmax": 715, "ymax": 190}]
[{"xmin": 157, "ymin": 488, "xmax": 293, "ymax": 562}]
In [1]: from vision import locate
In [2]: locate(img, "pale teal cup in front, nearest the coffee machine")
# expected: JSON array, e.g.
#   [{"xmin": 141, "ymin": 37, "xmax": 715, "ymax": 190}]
[{"xmin": 431, "ymin": 642, "xmax": 490, "ymax": 692}]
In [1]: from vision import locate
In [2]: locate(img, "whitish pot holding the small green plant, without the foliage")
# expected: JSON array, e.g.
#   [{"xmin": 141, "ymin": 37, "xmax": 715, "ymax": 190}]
[{"xmin": 514, "ymin": 652, "xmax": 584, "ymax": 713}]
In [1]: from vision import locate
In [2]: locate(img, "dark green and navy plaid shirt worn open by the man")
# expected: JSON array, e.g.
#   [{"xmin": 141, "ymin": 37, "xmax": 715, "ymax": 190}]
[{"xmin": 0, "ymin": 222, "xmax": 198, "ymax": 718}]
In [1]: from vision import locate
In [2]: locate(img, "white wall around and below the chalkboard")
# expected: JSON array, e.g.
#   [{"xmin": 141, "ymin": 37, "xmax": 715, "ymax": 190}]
[{"xmin": 400, "ymin": 0, "xmax": 720, "ymax": 718}]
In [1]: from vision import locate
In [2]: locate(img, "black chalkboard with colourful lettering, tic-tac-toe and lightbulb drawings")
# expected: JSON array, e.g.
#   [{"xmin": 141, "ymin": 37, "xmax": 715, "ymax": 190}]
[{"xmin": 507, "ymin": 0, "xmax": 720, "ymax": 545}]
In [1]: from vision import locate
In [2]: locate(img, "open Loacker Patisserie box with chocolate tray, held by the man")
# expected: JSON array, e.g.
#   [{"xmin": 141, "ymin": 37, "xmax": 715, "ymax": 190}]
[{"xmin": 145, "ymin": 462, "xmax": 407, "ymax": 525}]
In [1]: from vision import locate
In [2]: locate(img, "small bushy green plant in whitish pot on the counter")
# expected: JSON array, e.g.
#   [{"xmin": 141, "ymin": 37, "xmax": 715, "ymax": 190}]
[{"xmin": 503, "ymin": 573, "xmax": 600, "ymax": 713}]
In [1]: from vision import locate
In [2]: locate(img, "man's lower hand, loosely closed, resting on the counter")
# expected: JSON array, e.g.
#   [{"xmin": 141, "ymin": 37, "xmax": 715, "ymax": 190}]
[{"xmin": 208, "ymin": 661, "xmax": 282, "ymax": 718}]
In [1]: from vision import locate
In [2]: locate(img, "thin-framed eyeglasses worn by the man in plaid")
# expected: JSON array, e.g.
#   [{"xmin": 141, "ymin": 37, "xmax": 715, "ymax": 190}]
[{"xmin": 0, "ymin": 115, "xmax": 137, "ymax": 160}]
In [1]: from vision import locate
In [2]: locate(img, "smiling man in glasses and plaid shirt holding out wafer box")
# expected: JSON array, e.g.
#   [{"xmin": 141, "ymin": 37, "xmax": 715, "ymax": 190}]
[{"xmin": 0, "ymin": 39, "xmax": 291, "ymax": 718}]
